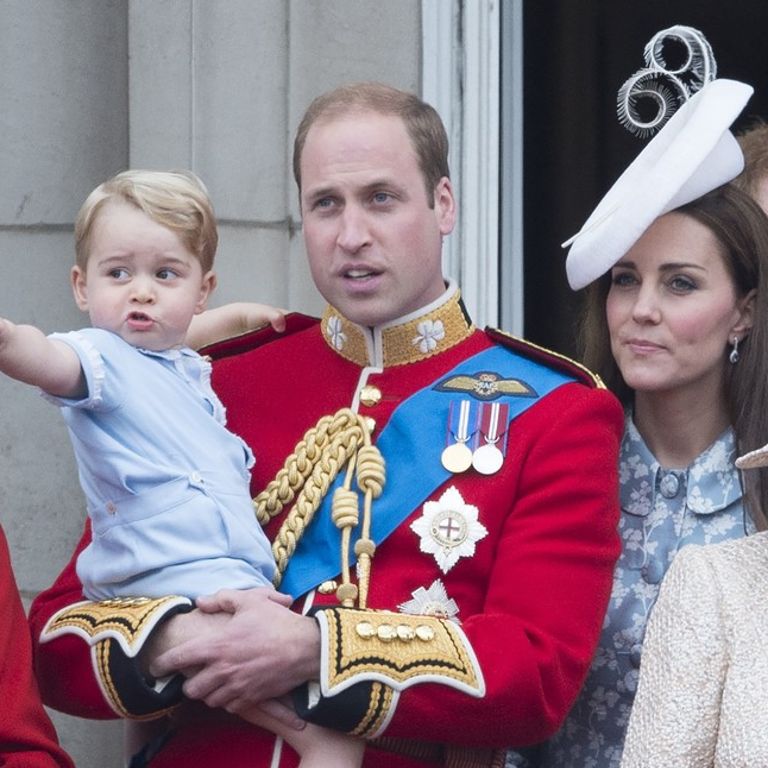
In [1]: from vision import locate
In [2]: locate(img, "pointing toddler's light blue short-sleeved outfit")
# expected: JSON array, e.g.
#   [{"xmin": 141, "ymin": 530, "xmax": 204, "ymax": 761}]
[{"xmin": 45, "ymin": 328, "xmax": 274, "ymax": 600}]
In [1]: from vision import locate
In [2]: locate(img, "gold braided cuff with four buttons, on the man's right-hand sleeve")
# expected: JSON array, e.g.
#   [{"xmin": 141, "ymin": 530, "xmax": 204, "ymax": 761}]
[{"xmin": 315, "ymin": 607, "xmax": 485, "ymax": 697}]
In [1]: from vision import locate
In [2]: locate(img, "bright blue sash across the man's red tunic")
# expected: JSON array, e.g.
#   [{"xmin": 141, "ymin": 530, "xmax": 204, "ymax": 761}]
[{"xmin": 280, "ymin": 346, "xmax": 574, "ymax": 597}]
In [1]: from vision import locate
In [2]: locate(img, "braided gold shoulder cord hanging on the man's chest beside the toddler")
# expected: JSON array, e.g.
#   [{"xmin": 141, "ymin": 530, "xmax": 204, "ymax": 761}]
[{"xmin": 253, "ymin": 408, "xmax": 385, "ymax": 608}]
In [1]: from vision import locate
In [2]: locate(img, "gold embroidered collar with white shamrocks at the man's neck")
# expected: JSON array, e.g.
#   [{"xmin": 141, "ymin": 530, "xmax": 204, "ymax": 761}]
[{"xmin": 320, "ymin": 282, "xmax": 475, "ymax": 368}]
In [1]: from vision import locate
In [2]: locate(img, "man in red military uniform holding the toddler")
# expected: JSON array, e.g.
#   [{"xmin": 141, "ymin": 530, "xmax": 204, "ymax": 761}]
[{"xmin": 32, "ymin": 84, "xmax": 623, "ymax": 768}]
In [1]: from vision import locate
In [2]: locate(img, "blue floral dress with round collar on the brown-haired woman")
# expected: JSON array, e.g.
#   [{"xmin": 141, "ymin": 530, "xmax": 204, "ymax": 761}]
[{"xmin": 506, "ymin": 416, "xmax": 755, "ymax": 768}]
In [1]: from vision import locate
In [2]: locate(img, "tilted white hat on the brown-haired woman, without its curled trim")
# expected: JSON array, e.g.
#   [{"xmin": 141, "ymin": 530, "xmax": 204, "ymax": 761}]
[{"xmin": 563, "ymin": 79, "xmax": 753, "ymax": 290}]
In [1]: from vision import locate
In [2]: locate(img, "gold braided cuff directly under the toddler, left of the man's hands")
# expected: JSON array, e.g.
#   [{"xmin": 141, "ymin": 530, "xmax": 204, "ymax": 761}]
[{"xmin": 40, "ymin": 595, "xmax": 192, "ymax": 658}]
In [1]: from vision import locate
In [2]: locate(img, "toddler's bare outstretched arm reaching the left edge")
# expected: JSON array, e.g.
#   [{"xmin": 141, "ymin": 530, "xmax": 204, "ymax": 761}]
[{"xmin": 0, "ymin": 318, "xmax": 86, "ymax": 398}]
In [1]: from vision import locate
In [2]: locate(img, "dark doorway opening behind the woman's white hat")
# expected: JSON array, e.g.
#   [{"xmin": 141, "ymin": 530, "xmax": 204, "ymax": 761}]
[{"xmin": 502, "ymin": 0, "xmax": 768, "ymax": 355}]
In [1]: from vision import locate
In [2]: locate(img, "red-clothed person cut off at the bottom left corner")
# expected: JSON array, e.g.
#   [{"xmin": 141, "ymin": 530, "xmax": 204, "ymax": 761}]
[{"xmin": 0, "ymin": 529, "xmax": 72, "ymax": 768}]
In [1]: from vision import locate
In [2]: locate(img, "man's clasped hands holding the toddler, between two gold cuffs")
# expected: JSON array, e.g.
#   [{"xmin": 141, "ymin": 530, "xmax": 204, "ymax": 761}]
[{"xmin": 150, "ymin": 587, "xmax": 320, "ymax": 714}]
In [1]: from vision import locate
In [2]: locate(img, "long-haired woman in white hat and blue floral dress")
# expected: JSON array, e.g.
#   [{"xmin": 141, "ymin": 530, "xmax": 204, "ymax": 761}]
[{"xmin": 538, "ymin": 72, "xmax": 768, "ymax": 768}]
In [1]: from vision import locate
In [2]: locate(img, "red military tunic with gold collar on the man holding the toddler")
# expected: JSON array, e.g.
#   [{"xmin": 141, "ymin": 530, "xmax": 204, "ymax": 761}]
[{"xmin": 32, "ymin": 290, "xmax": 623, "ymax": 768}]
